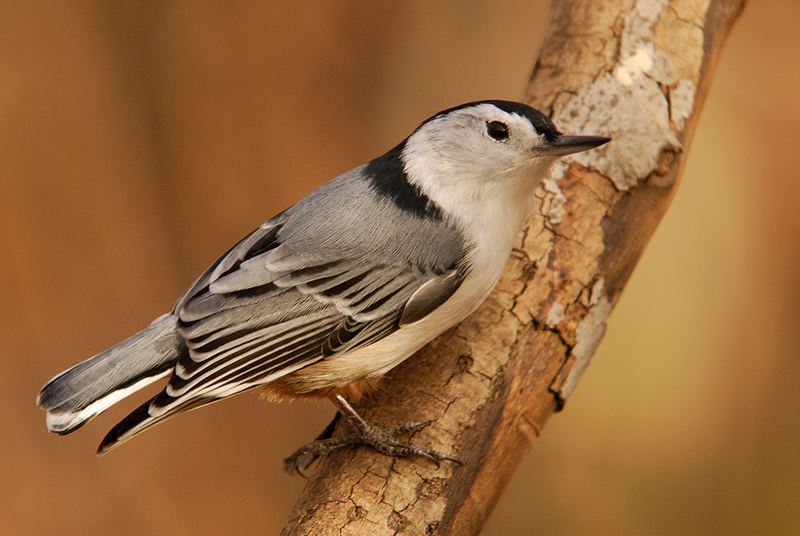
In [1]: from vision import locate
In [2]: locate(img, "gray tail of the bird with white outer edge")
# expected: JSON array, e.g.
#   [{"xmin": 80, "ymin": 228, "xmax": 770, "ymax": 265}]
[{"xmin": 36, "ymin": 314, "xmax": 186, "ymax": 434}]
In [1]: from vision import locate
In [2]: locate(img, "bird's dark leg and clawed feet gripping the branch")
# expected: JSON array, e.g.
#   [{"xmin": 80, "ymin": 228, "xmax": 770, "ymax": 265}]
[{"xmin": 283, "ymin": 395, "xmax": 461, "ymax": 476}]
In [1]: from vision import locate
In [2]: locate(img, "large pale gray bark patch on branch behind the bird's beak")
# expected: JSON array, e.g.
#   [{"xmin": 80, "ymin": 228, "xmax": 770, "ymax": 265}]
[{"xmin": 553, "ymin": 0, "xmax": 695, "ymax": 191}]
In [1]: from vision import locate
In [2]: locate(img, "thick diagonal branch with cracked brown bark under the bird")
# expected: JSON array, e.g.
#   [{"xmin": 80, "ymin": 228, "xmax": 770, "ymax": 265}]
[{"xmin": 283, "ymin": 0, "xmax": 744, "ymax": 536}]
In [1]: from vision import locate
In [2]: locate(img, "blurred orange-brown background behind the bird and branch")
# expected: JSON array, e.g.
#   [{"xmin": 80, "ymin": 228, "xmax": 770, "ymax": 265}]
[{"xmin": 0, "ymin": 0, "xmax": 800, "ymax": 536}]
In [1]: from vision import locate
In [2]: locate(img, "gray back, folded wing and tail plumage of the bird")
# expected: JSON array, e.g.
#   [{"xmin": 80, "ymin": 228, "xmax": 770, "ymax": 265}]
[{"xmin": 38, "ymin": 162, "xmax": 467, "ymax": 451}]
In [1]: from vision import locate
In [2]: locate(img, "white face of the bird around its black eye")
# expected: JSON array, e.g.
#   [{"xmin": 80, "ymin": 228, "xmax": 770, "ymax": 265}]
[{"xmin": 403, "ymin": 103, "xmax": 554, "ymax": 188}]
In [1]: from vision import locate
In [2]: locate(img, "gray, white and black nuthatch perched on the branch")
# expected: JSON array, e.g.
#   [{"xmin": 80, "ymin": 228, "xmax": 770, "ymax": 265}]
[{"xmin": 36, "ymin": 100, "xmax": 610, "ymax": 472}]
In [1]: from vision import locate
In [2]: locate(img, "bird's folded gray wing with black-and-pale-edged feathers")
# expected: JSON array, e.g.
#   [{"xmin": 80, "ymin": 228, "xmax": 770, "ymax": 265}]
[{"xmin": 150, "ymin": 174, "xmax": 465, "ymax": 418}]
